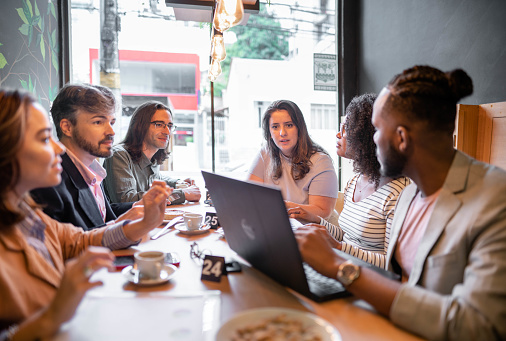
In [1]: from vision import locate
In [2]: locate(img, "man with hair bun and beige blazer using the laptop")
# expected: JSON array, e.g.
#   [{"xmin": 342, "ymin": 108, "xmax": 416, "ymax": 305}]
[{"xmin": 297, "ymin": 66, "xmax": 506, "ymax": 340}]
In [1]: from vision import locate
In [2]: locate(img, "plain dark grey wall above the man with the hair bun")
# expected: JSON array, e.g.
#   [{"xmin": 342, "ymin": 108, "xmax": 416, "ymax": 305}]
[{"xmin": 357, "ymin": 0, "xmax": 506, "ymax": 104}]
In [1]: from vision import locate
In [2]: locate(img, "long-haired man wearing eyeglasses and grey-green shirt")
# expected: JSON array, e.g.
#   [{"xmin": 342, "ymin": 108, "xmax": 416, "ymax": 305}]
[{"xmin": 104, "ymin": 101, "xmax": 201, "ymax": 204}]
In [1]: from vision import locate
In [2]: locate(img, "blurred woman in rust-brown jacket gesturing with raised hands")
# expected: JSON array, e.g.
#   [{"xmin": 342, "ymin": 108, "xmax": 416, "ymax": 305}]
[{"xmin": 0, "ymin": 89, "xmax": 170, "ymax": 340}]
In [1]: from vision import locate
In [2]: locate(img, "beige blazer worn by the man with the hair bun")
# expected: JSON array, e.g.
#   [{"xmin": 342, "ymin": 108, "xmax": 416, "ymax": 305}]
[{"xmin": 387, "ymin": 151, "xmax": 506, "ymax": 340}]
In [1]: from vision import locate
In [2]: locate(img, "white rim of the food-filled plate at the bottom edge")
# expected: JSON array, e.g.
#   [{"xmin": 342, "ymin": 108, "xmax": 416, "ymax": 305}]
[{"xmin": 216, "ymin": 308, "xmax": 342, "ymax": 341}]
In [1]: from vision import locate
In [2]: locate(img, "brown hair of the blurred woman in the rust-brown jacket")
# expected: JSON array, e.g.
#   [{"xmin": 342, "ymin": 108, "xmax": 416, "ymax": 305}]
[{"xmin": 0, "ymin": 89, "xmax": 36, "ymax": 227}]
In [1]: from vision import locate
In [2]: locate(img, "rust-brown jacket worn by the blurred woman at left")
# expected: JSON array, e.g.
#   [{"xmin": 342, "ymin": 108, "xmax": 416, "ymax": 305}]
[{"xmin": 0, "ymin": 210, "xmax": 106, "ymax": 325}]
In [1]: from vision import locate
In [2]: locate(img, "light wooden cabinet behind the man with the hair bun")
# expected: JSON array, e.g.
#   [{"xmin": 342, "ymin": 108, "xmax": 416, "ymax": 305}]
[{"xmin": 454, "ymin": 102, "xmax": 506, "ymax": 169}]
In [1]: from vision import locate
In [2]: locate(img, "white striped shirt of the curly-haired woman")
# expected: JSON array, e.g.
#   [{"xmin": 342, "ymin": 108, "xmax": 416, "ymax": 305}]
[{"xmin": 320, "ymin": 174, "xmax": 410, "ymax": 269}]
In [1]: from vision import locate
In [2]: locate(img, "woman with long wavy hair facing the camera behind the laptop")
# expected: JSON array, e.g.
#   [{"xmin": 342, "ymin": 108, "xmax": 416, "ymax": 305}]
[{"xmin": 249, "ymin": 100, "xmax": 337, "ymax": 218}]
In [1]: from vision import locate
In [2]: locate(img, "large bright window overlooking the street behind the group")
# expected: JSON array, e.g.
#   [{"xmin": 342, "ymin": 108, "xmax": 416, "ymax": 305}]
[{"xmin": 71, "ymin": 0, "xmax": 338, "ymax": 176}]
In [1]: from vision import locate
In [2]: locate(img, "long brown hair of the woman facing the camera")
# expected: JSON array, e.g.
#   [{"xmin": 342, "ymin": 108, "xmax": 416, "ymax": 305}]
[{"xmin": 262, "ymin": 100, "xmax": 328, "ymax": 180}]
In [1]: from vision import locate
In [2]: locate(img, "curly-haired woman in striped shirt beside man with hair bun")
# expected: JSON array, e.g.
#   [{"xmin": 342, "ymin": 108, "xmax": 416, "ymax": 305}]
[{"xmin": 288, "ymin": 94, "xmax": 410, "ymax": 268}]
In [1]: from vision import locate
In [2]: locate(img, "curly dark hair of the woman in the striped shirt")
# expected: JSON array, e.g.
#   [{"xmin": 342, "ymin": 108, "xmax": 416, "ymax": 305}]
[{"xmin": 344, "ymin": 94, "xmax": 381, "ymax": 189}]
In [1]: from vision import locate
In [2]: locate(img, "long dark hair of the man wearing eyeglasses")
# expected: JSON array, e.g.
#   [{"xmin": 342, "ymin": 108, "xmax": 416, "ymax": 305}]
[{"xmin": 122, "ymin": 101, "xmax": 172, "ymax": 165}]
